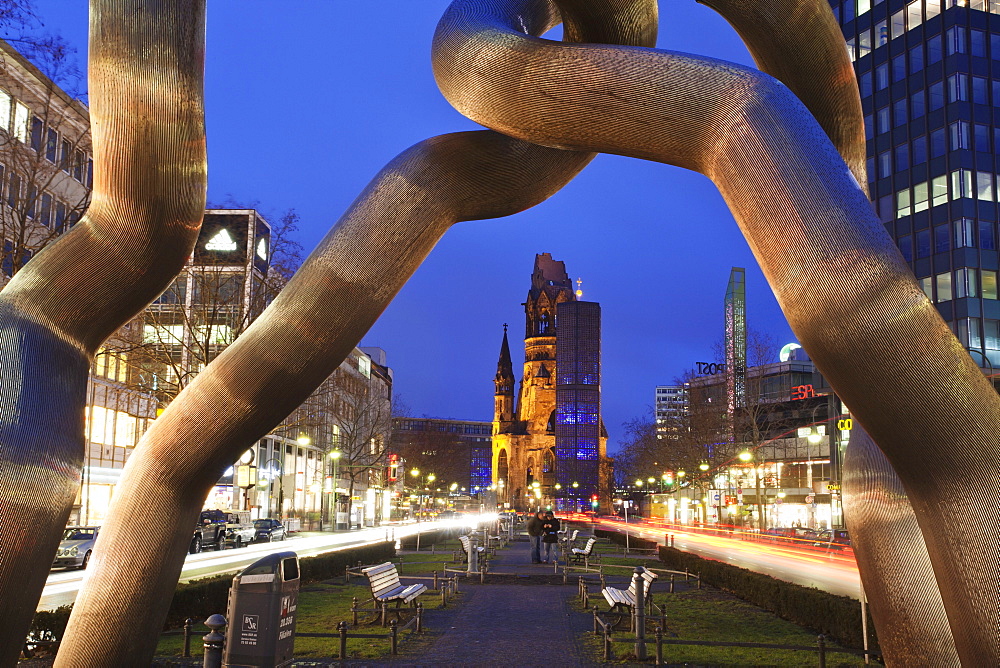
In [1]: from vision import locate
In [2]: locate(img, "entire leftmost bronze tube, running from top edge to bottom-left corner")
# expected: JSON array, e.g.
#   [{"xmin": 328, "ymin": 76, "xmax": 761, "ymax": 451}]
[{"xmin": 0, "ymin": 0, "xmax": 205, "ymax": 666}]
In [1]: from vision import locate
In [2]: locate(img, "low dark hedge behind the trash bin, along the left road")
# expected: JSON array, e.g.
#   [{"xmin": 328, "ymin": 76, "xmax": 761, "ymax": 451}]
[{"xmin": 31, "ymin": 541, "xmax": 396, "ymax": 640}]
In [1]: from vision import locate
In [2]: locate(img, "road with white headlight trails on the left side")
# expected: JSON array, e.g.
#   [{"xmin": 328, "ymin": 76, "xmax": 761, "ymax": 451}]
[{"xmin": 37, "ymin": 516, "xmax": 478, "ymax": 610}]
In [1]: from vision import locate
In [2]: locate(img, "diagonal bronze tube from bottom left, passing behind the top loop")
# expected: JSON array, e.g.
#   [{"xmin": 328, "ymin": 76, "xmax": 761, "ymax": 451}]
[{"xmin": 57, "ymin": 0, "xmax": 656, "ymax": 668}]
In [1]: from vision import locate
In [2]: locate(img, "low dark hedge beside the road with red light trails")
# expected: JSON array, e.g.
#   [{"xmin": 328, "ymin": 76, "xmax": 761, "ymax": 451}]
[{"xmin": 660, "ymin": 546, "xmax": 876, "ymax": 649}]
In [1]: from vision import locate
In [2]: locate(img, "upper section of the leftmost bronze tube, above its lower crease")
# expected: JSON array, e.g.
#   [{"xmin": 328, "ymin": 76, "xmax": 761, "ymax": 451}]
[{"xmin": 0, "ymin": 0, "xmax": 206, "ymax": 354}]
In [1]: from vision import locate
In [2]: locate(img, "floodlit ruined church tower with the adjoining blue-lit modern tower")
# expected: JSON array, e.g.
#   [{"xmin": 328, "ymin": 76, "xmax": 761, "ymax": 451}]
[{"xmin": 493, "ymin": 253, "xmax": 607, "ymax": 508}]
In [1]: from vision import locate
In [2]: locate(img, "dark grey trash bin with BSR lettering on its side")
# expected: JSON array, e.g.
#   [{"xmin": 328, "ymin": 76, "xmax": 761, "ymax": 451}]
[{"xmin": 223, "ymin": 552, "xmax": 299, "ymax": 668}]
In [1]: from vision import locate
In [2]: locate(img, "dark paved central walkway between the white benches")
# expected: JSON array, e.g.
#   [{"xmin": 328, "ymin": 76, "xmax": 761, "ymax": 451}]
[{"xmin": 402, "ymin": 537, "xmax": 600, "ymax": 668}]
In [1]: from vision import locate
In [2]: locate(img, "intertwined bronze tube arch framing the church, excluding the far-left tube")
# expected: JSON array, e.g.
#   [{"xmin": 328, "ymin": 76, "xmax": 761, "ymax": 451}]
[{"xmin": 0, "ymin": 0, "xmax": 1000, "ymax": 667}]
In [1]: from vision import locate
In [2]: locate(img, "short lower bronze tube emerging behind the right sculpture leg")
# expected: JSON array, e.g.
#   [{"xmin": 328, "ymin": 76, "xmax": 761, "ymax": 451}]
[{"xmin": 843, "ymin": 427, "xmax": 960, "ymax": 668}]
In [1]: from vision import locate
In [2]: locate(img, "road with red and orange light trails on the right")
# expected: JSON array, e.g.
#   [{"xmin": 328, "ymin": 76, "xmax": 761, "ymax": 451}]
[{"xmin": 584, "ymin": 518, "xmax": 861, "ymax": 599}]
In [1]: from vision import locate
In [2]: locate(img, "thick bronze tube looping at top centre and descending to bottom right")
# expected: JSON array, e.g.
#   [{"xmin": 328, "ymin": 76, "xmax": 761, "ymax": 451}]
[{"xmin": 435, "ymin": 0, "xmax": 1000, "ymax": 663}]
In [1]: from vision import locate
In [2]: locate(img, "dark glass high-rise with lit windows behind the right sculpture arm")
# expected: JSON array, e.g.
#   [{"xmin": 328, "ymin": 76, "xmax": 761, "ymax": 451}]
[{"xmin": 831, "ymin": 0, "xmax": 1000, "ymax": 372}]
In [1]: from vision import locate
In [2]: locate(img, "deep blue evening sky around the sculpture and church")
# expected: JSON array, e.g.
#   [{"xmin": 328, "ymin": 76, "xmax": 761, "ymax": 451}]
[{"xmin": 36, "ymin": 0, "xmax": 793, "ymax": 451}]
